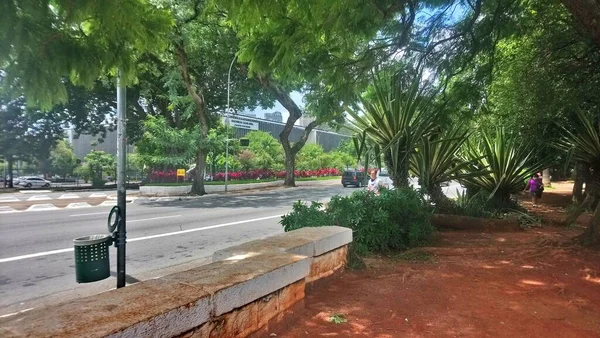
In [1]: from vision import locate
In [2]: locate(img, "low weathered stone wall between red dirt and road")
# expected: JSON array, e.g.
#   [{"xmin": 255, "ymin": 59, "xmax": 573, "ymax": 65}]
[{"xmin": 0, "ymin": 226, "xmax": 352, "ymax": 338}]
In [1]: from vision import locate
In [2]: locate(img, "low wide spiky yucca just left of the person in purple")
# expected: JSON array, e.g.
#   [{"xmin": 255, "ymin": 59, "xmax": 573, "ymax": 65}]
[{"xmin": 461, "ymin": 128, "xmax": 547, "ymax": 203}]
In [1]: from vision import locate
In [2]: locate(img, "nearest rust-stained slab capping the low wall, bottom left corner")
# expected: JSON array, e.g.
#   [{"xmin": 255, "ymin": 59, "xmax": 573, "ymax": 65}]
[{"xmin": 0, "ymin": 279, "xmax": 211, "ymax": 337}]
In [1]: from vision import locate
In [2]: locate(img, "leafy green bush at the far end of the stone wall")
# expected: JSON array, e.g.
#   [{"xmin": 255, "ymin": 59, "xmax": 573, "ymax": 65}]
[{"xmin": 281, "ymin": 189, "xmax": 433, "ymax": 256}]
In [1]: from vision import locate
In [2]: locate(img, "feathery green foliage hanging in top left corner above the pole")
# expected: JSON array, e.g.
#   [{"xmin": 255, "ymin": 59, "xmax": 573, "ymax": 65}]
[{"xmin": 0, "ymin": 0, "xmax": 171, "ymax": 108}]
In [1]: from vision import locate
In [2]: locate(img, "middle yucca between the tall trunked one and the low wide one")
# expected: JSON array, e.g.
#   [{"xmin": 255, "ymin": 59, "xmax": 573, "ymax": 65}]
[{"xmin": 410, "ymin": 128, "xmax": 486, "ymax": 204}]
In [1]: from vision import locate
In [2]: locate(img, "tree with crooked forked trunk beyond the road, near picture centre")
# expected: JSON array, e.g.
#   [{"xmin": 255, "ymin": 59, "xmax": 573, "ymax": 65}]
[{"xmin": 222, "ymin": 0, "xmax": 385, "ymax": 186}]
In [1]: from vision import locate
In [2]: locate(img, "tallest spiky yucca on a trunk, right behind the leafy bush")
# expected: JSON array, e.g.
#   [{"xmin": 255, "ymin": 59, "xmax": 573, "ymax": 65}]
[{"xmin": 347, "ymin": 74, "xmax": 437, "ymax": 187}]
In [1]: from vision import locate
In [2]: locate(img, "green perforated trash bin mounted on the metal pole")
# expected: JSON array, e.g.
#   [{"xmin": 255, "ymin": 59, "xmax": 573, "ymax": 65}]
[{"xmin": 73, "ymin": 235, "xmax": 112, "ymax": 283}]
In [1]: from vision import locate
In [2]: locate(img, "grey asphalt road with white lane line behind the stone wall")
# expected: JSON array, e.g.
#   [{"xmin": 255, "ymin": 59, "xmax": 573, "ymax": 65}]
[{"xmin": 0, "ymin": 185, "xmax": 354, "ymax": 317}]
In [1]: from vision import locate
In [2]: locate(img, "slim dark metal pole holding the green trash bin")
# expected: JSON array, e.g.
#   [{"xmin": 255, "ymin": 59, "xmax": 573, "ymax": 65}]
[{"xmin": 117, "ymin": 71, "xmax": 127, "ymax": 288}]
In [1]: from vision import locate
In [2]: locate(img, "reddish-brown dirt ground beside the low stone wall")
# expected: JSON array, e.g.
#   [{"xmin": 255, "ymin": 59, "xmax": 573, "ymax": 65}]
[{"xmin": 269, "ymin": 184, "xmax": 600, "ymax": 338}]
